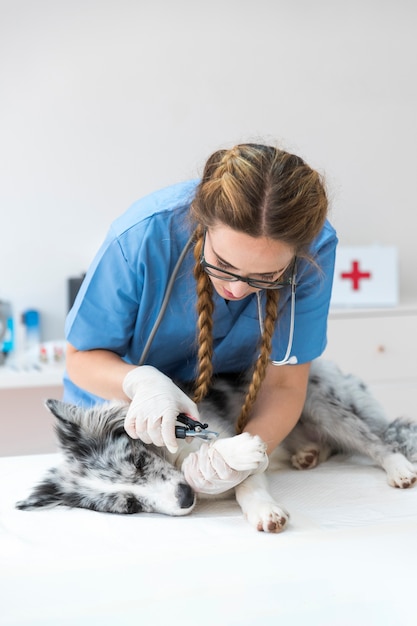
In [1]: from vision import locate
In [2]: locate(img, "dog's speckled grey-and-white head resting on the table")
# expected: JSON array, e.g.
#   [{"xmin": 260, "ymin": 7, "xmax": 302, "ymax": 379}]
[{"xmin": 16, "ymin": 400, "xmax": 195, "ymax": 515}]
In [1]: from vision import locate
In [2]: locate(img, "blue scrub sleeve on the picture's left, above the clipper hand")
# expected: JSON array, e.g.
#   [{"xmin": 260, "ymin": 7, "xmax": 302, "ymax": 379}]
[{"xmin": 65, "ymin": 228, "xmax": 142, "ymax": 356}]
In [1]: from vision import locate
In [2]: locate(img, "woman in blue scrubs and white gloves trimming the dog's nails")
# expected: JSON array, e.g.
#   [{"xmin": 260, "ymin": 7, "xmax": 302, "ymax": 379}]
[{"xmin": 64, "ymin": 144, "xmax": 337, "ymax": 493}]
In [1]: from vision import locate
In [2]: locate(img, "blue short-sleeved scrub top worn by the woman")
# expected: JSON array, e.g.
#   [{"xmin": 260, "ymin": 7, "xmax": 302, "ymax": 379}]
[{"xmin": 64, "ymin": 180, "xmax": 337, "ymax": 406}]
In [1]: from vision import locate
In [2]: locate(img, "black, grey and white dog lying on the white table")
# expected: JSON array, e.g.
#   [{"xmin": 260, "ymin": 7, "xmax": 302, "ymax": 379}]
[{"xmin": 16, "ymin": 359, "xmax": 417, "ymax": 532}]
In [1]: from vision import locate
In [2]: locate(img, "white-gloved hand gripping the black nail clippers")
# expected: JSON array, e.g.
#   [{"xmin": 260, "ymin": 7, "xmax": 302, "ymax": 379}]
[{"xmin": 123, "ymin": 365, "xmax": 199, "ymax": 452}]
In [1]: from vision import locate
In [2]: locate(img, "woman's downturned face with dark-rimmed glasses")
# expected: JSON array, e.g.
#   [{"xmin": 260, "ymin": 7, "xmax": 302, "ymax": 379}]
[{"xmin": 204, "ymin": 224, "xmax": 294, "ymax": 300}]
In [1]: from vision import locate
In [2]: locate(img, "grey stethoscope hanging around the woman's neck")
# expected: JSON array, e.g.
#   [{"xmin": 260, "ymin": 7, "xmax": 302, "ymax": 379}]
[{"xmin": 138, "ymin": 233, "xmax": 298, "ymax": 365}]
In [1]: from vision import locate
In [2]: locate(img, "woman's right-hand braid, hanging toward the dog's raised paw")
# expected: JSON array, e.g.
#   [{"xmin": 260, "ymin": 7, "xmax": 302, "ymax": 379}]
[{"xmin": 236, "ymin": 289, "xmax": 279, "ymax": 434}]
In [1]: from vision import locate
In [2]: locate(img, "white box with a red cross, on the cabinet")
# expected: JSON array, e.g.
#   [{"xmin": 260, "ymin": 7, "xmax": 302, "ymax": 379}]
[{"xmin": 331, "ymin": 245, "xmax": 399, "ymax": 307}]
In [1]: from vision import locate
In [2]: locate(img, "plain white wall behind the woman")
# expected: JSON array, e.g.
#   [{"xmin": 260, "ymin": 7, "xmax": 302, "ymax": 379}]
[{"xmin": 0, "ymin": 0, "xmax": 417, "ymax": 339}]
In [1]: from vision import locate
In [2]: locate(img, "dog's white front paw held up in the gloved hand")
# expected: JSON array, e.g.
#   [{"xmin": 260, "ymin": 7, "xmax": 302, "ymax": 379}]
[{"xmin": 212, "ymin": 433, "xmax": 268, "ymax": 472}]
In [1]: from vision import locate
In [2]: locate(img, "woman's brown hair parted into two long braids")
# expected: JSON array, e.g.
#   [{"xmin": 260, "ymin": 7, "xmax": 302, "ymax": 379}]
[{"xmin": 187, "ymin": 144, "xmax": 328, "ymax": 432}]
